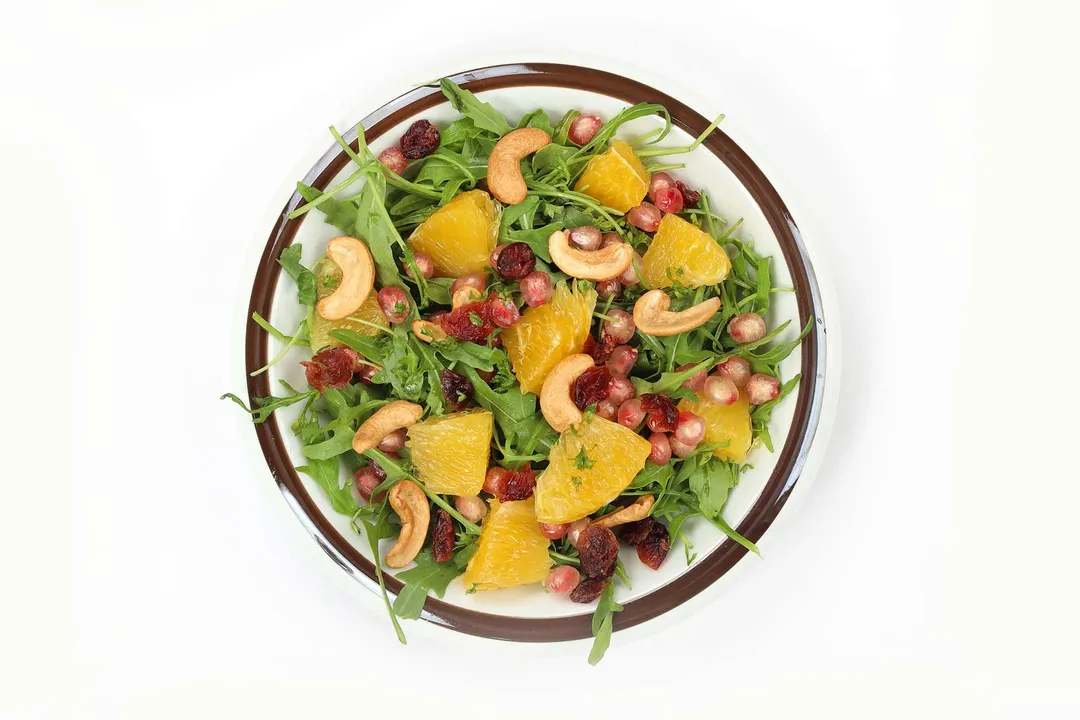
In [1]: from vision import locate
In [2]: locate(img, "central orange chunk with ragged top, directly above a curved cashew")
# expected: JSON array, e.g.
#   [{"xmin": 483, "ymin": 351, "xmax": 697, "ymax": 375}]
[{"xmin": 502, "ymin": 285, "xmax": 596, "ymax": 393}]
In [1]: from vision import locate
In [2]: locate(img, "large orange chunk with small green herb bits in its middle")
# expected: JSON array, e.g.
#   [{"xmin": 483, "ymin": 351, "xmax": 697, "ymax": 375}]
[{"xmin": 534, "ymin": 416, "xmax": 652, "ymax": 522}]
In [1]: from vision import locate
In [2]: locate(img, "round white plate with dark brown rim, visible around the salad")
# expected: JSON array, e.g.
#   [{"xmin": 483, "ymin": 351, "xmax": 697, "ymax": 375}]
[{"xmin": 245, "ymin": 64, "xmax": 826, "ymax": 642}]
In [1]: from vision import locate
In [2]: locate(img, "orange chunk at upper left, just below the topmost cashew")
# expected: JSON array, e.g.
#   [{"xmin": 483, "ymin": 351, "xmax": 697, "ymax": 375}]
[{"xmin": 408, "ymin": 190, "xmax": 500, "ymax": 277}]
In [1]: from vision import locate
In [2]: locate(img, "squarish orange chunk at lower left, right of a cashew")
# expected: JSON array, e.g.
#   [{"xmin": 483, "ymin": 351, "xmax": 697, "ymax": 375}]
[{"xmin": 406, "ymin": 410, "xmax": 494, "ymax": 495}]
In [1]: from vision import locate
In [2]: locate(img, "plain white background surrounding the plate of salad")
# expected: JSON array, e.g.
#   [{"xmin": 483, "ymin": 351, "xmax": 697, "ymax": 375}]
[{"xmin": 0, "ymin": 0, "xmax": 1080, "ymax": 718}]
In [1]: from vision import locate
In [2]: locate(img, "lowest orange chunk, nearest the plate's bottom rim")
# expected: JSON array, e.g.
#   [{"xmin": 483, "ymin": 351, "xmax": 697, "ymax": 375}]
[{"xmin": 461, "ymin": 498, "xmax": 552, "ymax": 590}]
